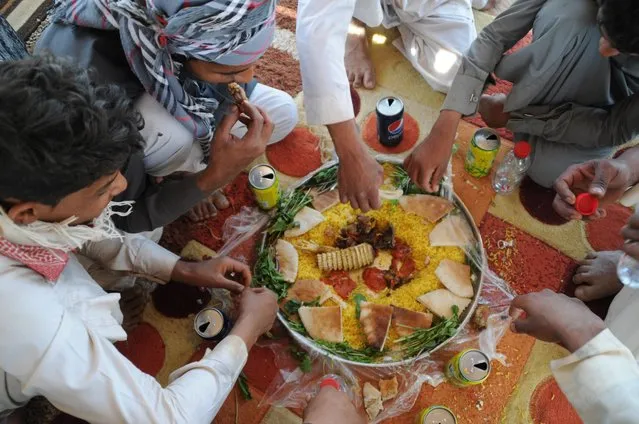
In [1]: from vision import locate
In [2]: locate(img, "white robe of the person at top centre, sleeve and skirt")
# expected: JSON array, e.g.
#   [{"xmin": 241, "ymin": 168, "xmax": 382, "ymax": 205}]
[{"xmin": 297, "ymin": 0, "xmax": 477, "ymax": 125}]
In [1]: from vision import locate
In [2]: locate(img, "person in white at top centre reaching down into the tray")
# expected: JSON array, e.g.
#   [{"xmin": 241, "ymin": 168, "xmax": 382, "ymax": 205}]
[{"xmin": 297, "ymin": 0, "xmax": 476, "ymax": 211}]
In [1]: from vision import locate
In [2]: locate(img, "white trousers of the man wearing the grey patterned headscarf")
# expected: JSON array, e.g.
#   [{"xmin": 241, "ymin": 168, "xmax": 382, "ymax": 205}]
[{"xmin": 136, "ymin": 84, "xmax": 297, "ymax": 177}]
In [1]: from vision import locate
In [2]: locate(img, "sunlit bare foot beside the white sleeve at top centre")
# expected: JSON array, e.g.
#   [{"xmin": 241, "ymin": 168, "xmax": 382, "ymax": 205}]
[{"xmin": 344, "ymin": 20, "xmax": 375, "ymax": 89}]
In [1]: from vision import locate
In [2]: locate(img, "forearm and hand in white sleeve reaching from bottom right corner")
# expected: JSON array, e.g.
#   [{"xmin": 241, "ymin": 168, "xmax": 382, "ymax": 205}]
[{"xmin": 511, "ymin": 289, "xmax": 639, "ymax": 424}]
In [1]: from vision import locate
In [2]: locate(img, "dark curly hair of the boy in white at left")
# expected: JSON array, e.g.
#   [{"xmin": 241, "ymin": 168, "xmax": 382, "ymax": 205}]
[{"xmin": 0, "ymin": 57, "xmax": 143, "ymax": 206}]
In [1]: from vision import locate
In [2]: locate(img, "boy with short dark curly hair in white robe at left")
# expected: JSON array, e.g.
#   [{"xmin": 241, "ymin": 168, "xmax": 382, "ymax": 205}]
[{"xmin": 0, "ymin": 58, "xmax": 277, "ymax": 423}]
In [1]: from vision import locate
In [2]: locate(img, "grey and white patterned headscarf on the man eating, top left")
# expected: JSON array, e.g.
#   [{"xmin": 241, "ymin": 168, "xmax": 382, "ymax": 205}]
[{"xmin": 53, "ymin": 0, "xmax": 277, "ymax": 157}]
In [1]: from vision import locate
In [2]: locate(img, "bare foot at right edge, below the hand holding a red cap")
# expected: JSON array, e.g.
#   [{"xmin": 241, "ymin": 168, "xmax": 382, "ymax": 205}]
[{"xmin": 573, "ymin": 251, "xmax": 623, "ymax": 302}]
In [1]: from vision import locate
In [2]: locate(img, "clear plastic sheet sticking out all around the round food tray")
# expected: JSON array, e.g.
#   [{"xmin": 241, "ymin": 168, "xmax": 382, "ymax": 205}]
[{"xmin": 219, "ymin": 161, "xmax": 515, "ymax": 423}]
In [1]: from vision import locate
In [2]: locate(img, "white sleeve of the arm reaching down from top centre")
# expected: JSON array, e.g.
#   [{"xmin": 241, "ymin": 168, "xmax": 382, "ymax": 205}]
[{"xmin": 296, "ymin": 0, "xmax": 356, "ymax": 125}]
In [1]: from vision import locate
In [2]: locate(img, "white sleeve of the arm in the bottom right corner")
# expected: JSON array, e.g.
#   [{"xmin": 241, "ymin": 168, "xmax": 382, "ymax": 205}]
[{"xmin": 550, "ymin": 328, "xmax": 639, "ymax": 424}]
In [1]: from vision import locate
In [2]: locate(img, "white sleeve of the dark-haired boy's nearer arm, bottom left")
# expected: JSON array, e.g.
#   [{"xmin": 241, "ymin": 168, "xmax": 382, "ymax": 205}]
[{"xmin": 0, "ymin": 270, "xmax": 248, "ymax": 424}]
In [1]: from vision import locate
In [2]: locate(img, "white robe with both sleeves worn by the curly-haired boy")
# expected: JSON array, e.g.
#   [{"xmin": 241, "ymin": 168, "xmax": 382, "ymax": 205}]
[{"xmin": 0, "ymin": 235, "xmax": 248, "ymax": 424}]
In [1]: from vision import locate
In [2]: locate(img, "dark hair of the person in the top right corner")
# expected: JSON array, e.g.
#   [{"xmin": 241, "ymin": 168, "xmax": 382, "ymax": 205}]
[{"xmin": 599, "ymin": 0, "xmax": 639, "ymax": 54}]
